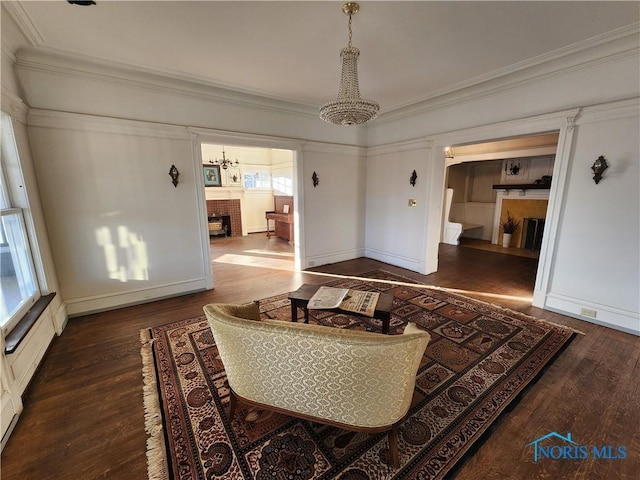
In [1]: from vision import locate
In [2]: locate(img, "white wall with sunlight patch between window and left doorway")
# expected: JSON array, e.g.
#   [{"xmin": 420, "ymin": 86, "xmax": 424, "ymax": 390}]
[{"xmin": 29, "ymin": 110, "xmax": 210, "ymax": 314}]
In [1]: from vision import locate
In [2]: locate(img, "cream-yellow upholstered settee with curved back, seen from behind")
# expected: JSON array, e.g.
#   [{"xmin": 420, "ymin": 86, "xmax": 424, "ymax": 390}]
[{"xmin": 204, "ymin": 303, "xmax": 430, "ymax": 468}]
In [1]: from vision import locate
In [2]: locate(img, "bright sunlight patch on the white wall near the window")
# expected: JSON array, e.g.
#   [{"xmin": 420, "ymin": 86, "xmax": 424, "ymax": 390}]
[{"xmin": 96, "ymin": 225, "xmax": 149, "ymax": 282}]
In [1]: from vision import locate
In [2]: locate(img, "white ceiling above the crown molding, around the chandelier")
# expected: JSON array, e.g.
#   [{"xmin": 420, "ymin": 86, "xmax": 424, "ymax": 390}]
[{"xmin": 2, "ymin": 0, "xmax": 640, "ymax": 111}]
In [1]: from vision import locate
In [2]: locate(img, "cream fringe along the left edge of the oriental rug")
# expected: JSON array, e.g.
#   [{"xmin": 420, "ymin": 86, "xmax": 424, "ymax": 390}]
[{"xmin": 140, "ymin": 329, "xmax": 169, "ymax": 480}]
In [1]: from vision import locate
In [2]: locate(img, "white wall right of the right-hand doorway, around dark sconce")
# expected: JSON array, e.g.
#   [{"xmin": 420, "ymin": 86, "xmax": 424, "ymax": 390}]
[{"xmin": 547, "ymin": 102, "xmax": 640, "ymax": 334}]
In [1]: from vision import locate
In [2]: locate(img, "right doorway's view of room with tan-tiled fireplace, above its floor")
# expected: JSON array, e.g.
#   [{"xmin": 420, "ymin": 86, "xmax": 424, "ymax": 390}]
[{"xmin": 441, "ymin": 132, "xmax": 559, "ymax": 259}]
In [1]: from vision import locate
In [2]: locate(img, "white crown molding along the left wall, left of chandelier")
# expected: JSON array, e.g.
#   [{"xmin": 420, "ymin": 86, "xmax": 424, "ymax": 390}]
[{"xmin": 15, "ymin": 47, "xmax": 318, "ymax": 118}]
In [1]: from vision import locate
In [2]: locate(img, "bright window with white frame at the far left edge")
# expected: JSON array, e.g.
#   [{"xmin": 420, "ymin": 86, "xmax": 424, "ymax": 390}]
[{"xmin": 0, "ymin": 115, "xmax": 40, "ymax": 332}]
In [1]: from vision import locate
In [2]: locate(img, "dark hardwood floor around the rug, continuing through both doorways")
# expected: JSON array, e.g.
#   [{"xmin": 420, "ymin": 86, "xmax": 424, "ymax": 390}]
[{"xmin": 0, "ymin": 234, "xmax": 640, "ymax": 480}]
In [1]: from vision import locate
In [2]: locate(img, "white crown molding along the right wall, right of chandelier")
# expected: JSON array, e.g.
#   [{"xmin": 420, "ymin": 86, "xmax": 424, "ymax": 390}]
[{"xmin": 376, "ymin": 22, "xmax": 640, "ymax": 124}]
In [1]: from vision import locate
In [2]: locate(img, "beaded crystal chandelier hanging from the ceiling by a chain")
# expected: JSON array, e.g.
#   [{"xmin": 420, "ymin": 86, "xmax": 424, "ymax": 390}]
[{"xmin": 320, "ymin": 2, "xmax": 380, "ymax": 125}]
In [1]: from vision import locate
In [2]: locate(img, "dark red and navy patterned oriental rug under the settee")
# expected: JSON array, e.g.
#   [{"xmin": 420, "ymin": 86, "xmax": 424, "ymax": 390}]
[{"xmin": 141, "ymin": 270, "xmax": 575, "ymax": 480}]
